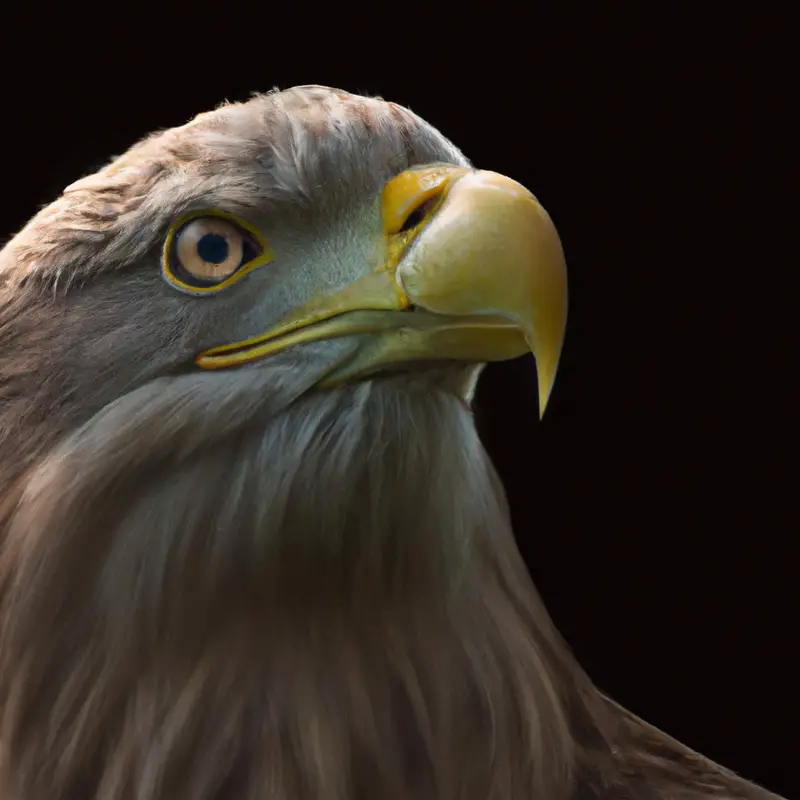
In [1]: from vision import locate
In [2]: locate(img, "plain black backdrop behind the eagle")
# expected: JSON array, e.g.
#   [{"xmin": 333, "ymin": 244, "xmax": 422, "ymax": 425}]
[{"xmin": 0, "ymin": 3, "xmax": 798, "ymax": 797}]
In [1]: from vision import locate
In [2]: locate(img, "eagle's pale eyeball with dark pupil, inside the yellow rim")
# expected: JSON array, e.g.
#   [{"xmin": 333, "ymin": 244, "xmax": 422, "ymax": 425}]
[{"xmin": 167, "ymin": 216, "xmax": 260, "ymax": 289}]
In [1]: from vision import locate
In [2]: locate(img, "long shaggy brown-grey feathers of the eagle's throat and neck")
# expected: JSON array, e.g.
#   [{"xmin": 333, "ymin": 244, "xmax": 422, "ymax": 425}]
[{"xmin": 0, "ymin": 378, "xmax": 608, "ymax": 800}]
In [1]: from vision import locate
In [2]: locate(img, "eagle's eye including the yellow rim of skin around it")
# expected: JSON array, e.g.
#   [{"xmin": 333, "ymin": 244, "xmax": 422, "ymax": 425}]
[{"xmin": 162, "ymin": 212, "xmax": 269, "ymax": 294}]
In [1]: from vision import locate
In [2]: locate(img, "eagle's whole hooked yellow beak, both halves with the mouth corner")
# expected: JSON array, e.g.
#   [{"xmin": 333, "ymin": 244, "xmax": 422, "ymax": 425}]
[{"xmin": 196, "ymin": 167, "xmax": 567, "ymax": 414}]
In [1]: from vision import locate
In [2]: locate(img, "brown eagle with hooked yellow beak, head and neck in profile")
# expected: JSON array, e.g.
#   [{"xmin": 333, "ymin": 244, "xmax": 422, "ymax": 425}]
[{"xmin": 0, "ymin": 86, "xmax": 776, "ymax": 800}]
